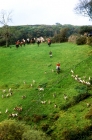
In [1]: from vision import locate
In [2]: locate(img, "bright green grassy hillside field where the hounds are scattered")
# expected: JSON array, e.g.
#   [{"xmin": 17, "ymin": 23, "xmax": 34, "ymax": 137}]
[{"xmin": 0, "ymin": 43, "xmax": 92, "ymax": 140}]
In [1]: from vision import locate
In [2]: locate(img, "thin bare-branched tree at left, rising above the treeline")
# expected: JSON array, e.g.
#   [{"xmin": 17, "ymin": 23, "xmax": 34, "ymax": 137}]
[{"xmin": 0, "ymin": 10, "xmax": 12, "ymax": 47}]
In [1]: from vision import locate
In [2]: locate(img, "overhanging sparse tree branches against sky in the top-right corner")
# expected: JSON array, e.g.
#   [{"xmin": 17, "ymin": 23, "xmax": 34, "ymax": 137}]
[{"xmin": 74, "ymin": 0, "xmax": 92, "ymax": 20}]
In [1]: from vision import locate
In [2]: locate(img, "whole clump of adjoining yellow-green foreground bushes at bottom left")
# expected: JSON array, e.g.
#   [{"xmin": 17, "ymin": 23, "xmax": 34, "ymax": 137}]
[{"xmin": 0, "ymin": 120, "xmax": 50, "ymax": 140}]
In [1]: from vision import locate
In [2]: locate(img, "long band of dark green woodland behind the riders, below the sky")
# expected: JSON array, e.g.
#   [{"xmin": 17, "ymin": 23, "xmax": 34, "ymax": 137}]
[{"xmin": 0, "ymin": 23, "xmax": 92, "ymax": 46}]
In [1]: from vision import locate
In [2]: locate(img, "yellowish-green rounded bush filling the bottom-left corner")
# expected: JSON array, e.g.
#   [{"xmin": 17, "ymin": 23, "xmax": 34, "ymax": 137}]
[{"xmin": 0, "ymin": 120, "xmax": 29, "ymax": 140}]
